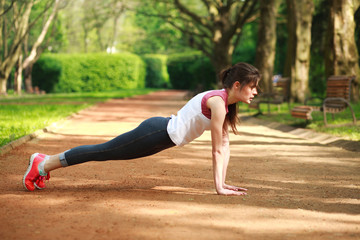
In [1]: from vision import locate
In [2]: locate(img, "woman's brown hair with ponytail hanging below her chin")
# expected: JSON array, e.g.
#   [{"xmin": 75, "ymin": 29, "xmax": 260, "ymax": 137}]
[{"xmin": 220, "ymin": 62, "xmax": 261, "ymax": 134}]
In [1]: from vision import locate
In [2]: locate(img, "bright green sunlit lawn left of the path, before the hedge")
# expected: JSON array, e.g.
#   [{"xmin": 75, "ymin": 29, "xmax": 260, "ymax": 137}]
[{"xmin": 0, "ymin": 89, "xmax": 152, "ymax": 147}]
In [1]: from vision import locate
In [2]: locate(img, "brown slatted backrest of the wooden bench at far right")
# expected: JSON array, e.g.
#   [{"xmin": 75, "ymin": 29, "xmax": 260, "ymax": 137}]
[{"xmin": 326, "ymin": 76, "xmax": 355, "ymax": 108}]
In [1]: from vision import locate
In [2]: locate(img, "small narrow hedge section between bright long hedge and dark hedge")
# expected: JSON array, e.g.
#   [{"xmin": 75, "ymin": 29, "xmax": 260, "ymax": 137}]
[{"xmin": 143, "ymin": 54, "xmax": 170, "ymax": 88}]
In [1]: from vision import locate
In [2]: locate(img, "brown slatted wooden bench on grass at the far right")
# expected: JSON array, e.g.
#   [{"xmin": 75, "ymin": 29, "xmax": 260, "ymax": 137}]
[{"xmin": 291, "ymin": 76, "xmax": 356, "ymax": 126}]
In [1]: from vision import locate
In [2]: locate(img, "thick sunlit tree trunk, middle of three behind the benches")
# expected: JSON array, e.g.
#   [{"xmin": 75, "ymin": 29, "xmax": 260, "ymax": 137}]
[{"xmin": 284, "ymin": 0, "xmax": 314, "ymax": 102}]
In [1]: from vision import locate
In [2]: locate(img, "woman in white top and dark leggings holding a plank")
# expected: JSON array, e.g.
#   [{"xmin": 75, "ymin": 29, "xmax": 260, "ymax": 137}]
[{"xmin": 23, "ymin": 63, "xmax": 260, "ymax": 195}]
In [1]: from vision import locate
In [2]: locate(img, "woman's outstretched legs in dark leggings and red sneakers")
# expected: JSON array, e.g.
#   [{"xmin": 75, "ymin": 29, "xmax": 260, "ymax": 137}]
[{"xmin": 23, "ymin": 117, "xmax": 175, "ymax": 191}]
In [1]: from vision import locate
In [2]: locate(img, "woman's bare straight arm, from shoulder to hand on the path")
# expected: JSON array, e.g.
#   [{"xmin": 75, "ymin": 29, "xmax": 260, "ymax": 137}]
[{"xmin": 207, "ymin": 96, "xmax": 245, "ymax": 195}]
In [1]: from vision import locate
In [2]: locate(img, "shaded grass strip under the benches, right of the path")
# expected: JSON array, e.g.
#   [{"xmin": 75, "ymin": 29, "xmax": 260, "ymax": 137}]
[{"xmin": 240, "ymin": 102, "xmax": 360, "ymax": 141}]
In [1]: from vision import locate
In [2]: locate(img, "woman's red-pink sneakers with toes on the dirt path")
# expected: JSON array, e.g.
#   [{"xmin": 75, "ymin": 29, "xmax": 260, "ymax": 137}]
[{"xmin": 23, "ymin": 153, "xmax": 50, "ymax": 191}]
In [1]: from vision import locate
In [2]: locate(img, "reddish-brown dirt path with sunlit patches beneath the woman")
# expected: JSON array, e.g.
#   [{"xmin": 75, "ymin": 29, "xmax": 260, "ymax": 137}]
[{"xmin": 0, "ymin": 91, "xmax": 360, "ymax": 240}]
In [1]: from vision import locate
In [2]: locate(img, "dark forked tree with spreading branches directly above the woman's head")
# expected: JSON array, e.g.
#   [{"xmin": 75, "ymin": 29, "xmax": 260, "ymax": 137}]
[{"xmin": 136, "ymin": 0, "xmax": 258, "ymax": 83}]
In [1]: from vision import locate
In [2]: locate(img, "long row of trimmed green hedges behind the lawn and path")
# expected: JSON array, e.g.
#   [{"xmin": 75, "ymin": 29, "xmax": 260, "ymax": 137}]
[{"xmin": 32, "ymin": 52, "xmax": 216, "ymax": 92}]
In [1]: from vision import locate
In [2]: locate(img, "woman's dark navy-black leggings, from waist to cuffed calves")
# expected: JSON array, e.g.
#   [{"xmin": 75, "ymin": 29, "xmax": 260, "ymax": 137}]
[{"xmin": 60, "ymin": 117, "xmax": 175, "ymax": 167}]
